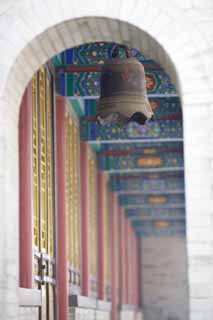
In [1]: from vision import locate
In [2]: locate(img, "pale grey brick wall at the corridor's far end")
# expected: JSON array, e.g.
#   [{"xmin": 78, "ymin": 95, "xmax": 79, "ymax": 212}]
[{"xmin": 140, "ymin": 236, "xmax": 189, "ymax": 320}]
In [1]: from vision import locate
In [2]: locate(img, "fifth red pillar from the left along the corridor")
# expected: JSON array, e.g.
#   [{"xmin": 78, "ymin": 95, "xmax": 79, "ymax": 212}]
[{"xmin": 111, "ymin": 192, "xmax": 118, "ymax": 320}]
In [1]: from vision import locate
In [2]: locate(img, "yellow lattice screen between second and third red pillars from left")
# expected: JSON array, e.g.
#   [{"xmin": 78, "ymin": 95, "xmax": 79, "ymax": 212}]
[{"xmin": 66, "ymin": 113, "xmax": 81, "ymax": 286}]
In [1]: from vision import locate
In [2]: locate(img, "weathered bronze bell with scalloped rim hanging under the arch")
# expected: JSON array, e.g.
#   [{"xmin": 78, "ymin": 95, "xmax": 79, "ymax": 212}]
[{"xmin": 96, "ymin": 46, "xmax": 153, "ymax": 125}]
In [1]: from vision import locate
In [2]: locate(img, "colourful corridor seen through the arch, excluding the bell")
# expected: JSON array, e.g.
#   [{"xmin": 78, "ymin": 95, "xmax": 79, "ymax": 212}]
[{"xmin": 19, "ymin": 42, "xmax": 187, "ymax": 320}]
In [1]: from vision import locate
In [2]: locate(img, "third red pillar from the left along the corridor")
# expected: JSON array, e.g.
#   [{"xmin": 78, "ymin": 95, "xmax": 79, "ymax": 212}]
[{"xmin": 80, "ymin": 141, "xmax": 89, "ymax": 296}]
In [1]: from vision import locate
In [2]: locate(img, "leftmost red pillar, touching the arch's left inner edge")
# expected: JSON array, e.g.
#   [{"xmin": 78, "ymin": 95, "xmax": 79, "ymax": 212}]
[{"xmin": 19, "ymin": 83, "xmax": 33, "ymax": 288}]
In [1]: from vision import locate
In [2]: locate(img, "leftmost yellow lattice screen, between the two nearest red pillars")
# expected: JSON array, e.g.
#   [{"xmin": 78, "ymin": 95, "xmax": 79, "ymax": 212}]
[{"xmin": 32, "ymin": 67, "xmax": 55, "ymax": 320}]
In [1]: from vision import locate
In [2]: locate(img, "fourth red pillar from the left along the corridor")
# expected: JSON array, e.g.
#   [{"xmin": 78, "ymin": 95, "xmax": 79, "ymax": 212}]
[{"xmin": 98, "ymin": 170, "xmax": 106, "ymax": 300}]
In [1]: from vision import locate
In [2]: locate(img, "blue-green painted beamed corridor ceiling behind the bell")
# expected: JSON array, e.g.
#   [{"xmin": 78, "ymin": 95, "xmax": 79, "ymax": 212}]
[{"xmin": 53, "ymin": 42, "xmax": 185, "ymax": 236}]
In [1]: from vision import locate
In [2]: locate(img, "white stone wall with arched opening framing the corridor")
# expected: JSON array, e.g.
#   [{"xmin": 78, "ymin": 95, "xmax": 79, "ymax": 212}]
[{"xmin": 0, "ymin": 0, "xmax": 213, "ymax": 320}]
